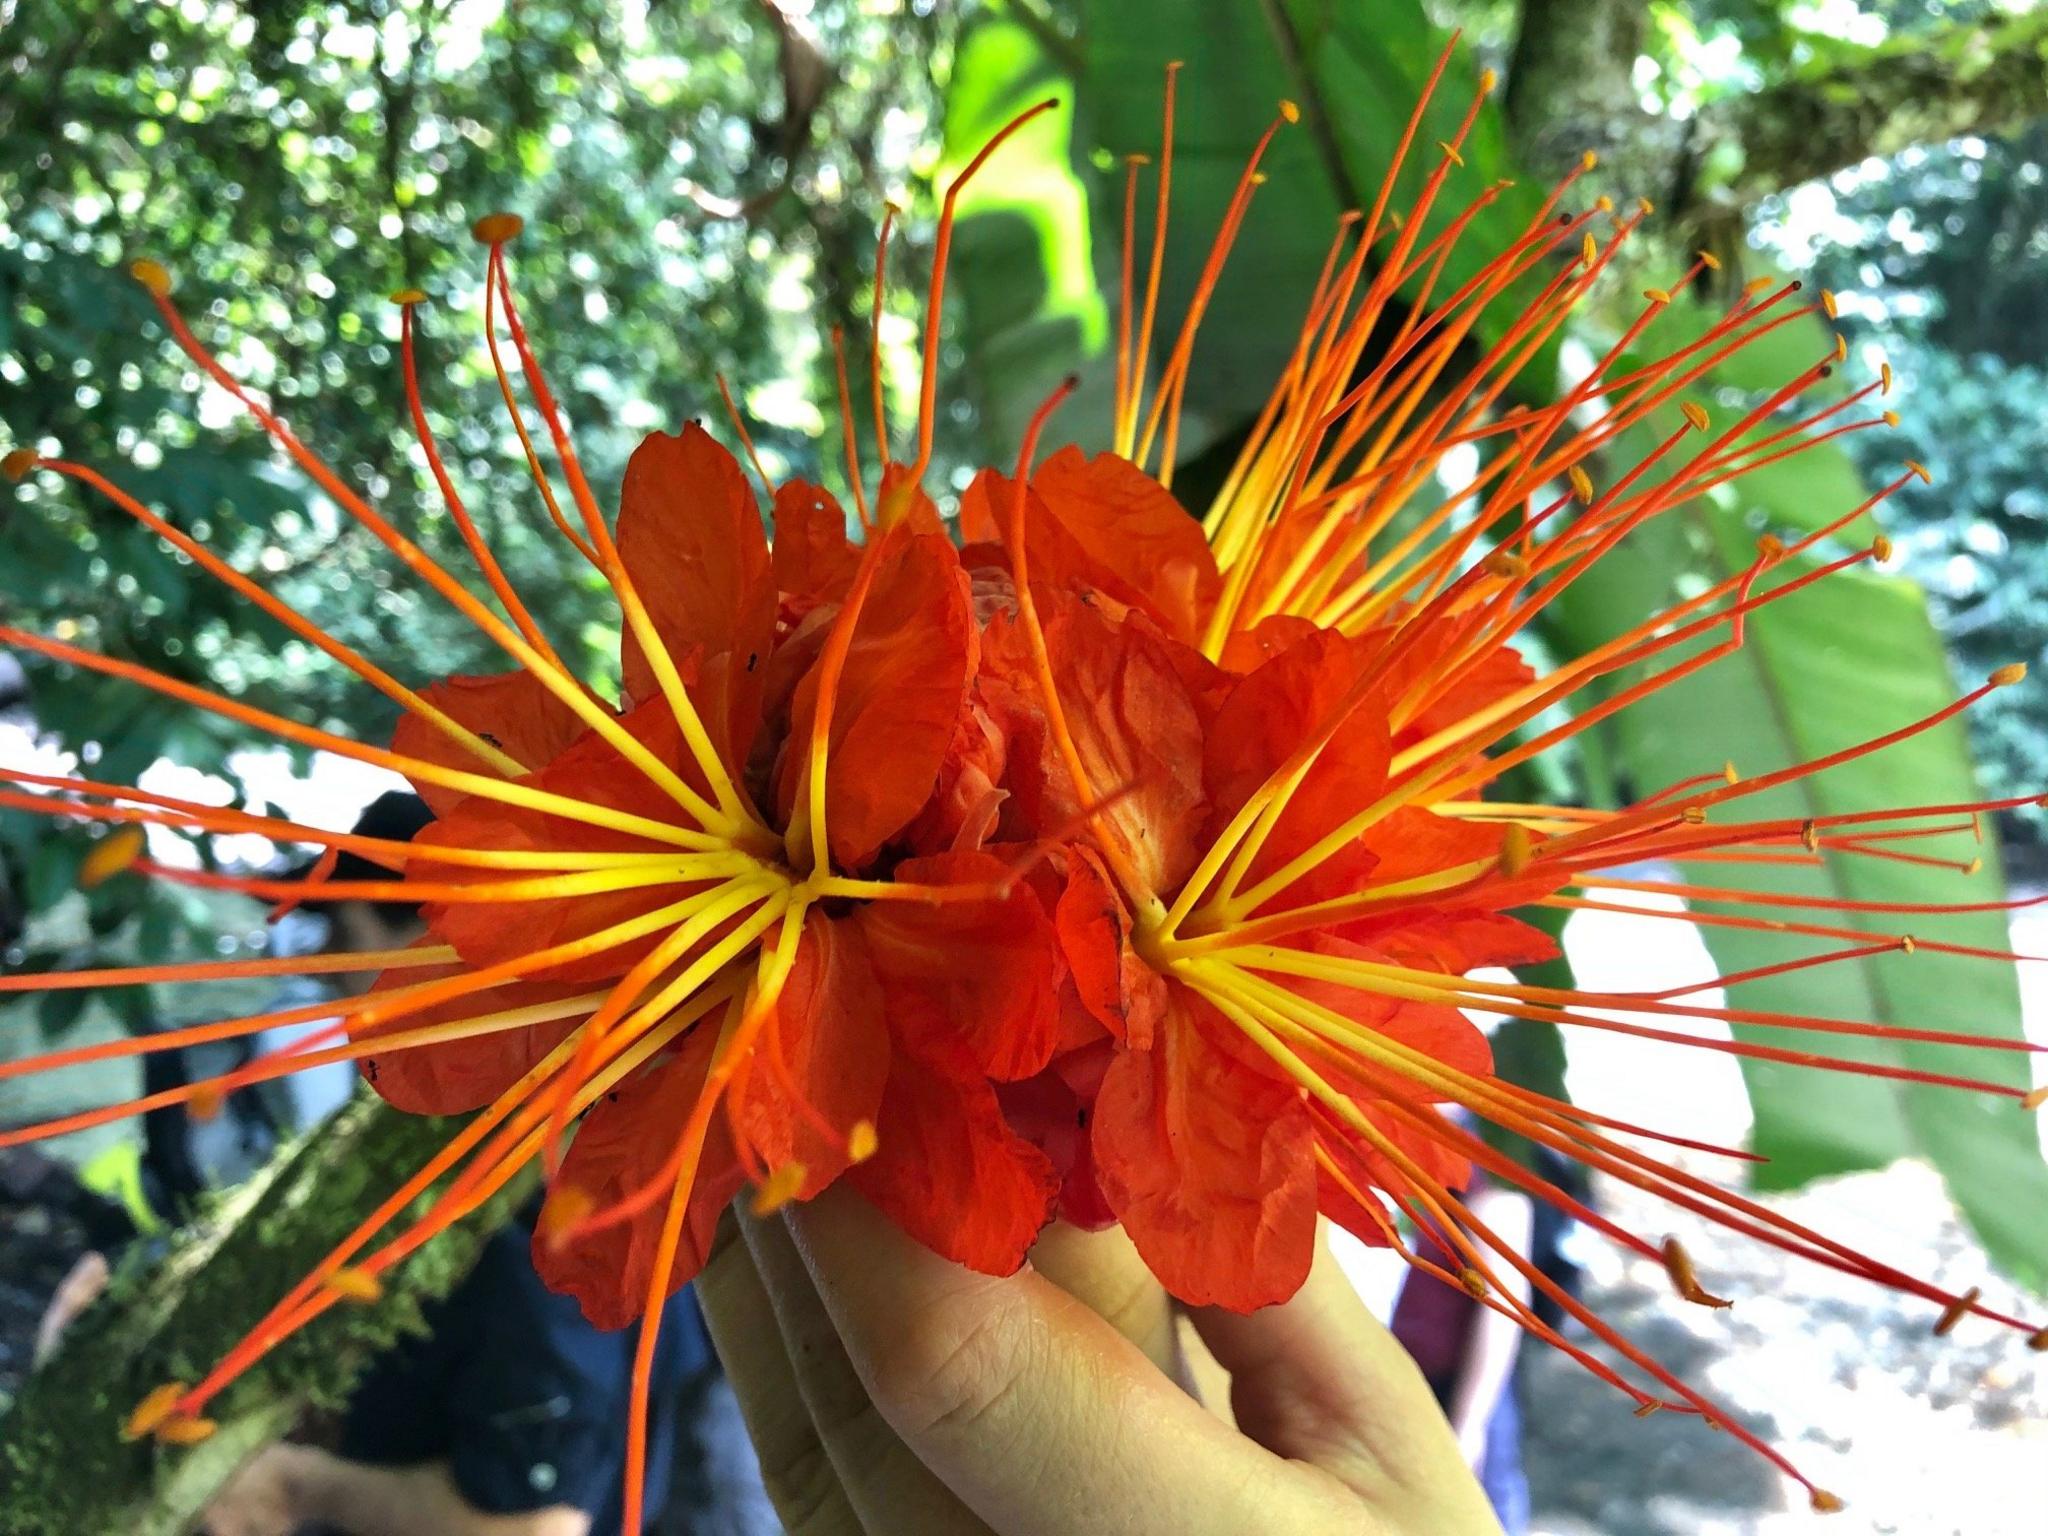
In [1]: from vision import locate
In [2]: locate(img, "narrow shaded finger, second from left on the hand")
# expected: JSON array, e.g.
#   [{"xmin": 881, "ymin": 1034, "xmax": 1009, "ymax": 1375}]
[{"xmin": 739, "ymin": 1196, "xmax": 987, "ymax": 1536}]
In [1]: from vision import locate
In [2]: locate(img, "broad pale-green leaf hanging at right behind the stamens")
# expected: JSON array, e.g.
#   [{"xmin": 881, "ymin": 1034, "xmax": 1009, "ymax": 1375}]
[{"xmin": 1552, "ymin": 358, "xmax": 2048, "ymax": 1286}]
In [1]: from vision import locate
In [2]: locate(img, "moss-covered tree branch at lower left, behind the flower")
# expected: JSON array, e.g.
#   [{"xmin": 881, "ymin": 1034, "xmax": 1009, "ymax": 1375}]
[{"xmin": 0, "ymin": 1090, "xmax": 524, "ymax": 1536}]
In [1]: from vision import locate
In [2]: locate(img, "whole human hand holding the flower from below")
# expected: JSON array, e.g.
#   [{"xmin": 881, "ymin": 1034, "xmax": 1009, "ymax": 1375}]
[{"xmin": 698, "ymin": 1190, "xmax": 1499, "ymax": 1536}]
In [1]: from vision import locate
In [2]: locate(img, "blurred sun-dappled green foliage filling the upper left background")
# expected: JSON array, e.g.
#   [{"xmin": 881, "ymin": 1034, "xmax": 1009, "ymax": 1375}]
[{"xmin": 0, "ymin": 0, "xmax": 944, "ymax": 961}]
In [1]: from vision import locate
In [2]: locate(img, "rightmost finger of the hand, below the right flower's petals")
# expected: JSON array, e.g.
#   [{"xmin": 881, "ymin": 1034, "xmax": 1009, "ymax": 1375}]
[{"xmin": 1190, "ymin": 1241, "xmax": 1499, "ymax": 1532}]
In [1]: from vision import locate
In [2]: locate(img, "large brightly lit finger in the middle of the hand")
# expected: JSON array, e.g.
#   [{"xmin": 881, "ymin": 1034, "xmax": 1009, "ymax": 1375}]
[{"xmin": 788, "ymin": 1190, "xmax": 1380, "ymax": 1536}]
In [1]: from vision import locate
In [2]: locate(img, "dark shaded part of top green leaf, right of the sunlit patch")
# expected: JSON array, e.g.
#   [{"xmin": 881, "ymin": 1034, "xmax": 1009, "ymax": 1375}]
[{"xmin": 1081, "ymin": 0, "xmax": 1538, "ymax": 436}]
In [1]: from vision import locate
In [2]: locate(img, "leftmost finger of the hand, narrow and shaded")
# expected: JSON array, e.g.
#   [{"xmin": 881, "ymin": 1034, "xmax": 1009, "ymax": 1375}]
[{"xmin": 696, "ymin": 1210, "xmax": 862, "ymax": 1536}]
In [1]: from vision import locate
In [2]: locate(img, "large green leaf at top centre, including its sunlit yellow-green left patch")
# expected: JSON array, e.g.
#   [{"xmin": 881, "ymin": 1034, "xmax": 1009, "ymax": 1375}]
[{"xmin": 946, "ymin": 0, "xmax": 1538, "ymax": 468}]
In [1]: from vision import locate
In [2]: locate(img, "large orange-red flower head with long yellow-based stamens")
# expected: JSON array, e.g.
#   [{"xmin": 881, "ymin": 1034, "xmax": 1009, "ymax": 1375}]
[{"xmin": 0, "ymin": 41, "xmax": 2048, "ymax": 1528}]
